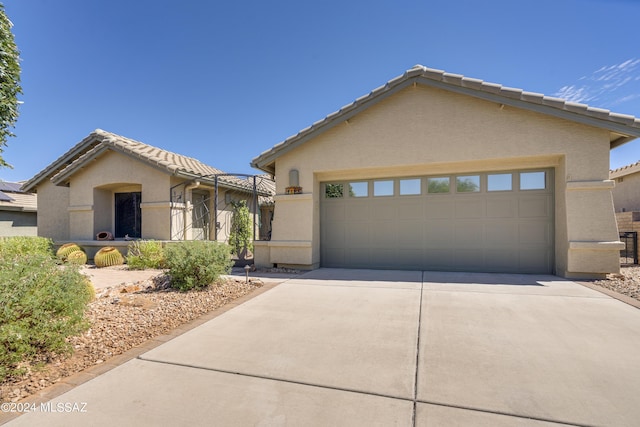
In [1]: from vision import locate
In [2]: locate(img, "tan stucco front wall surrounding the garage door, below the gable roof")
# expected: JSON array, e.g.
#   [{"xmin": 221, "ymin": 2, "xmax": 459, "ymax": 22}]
[{"xmin": 258, "ymin": 86, "xmax": 619, "ymax": 276}]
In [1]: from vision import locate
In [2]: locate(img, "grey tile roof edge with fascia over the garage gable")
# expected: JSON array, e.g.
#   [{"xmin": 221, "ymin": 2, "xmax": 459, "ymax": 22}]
[{"xmin": 251, "ymin": 65, "xmax": 640, "ymax": 173}]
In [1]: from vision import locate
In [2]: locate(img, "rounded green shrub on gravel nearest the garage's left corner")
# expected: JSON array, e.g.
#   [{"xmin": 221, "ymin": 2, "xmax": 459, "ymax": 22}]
[{"xmin": 165, "ymin": 240, "xmax": 233, "ymax": 291}]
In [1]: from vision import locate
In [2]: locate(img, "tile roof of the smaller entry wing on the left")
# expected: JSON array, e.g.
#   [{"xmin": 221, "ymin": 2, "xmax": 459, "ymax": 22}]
[{"xmin": 25, "ymin": 129, "xmax": 268, "ymax": 196}]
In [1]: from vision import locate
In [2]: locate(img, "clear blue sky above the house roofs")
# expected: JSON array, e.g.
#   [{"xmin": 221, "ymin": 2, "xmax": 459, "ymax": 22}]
[{"xmin": 0, "ymin": 0, "xmax": 640, "ymax": 181}]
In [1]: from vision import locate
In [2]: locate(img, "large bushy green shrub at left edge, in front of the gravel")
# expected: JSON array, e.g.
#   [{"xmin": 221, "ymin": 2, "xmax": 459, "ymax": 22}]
[{"xmin": 0, "ymin": 254, "xmax": 93, "ymax": 382}]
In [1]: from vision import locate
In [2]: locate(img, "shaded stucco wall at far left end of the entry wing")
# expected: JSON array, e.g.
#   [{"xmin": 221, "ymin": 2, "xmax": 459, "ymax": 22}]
[{"xmin": 38, "ymin": 181, "xmax": 70, "ymax": 241}]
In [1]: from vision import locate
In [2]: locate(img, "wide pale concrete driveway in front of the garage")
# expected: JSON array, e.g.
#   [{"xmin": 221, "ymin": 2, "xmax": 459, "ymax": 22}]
[{"xmin": 9, "ymin": 269, "xmax": 640, "ymax": 427}]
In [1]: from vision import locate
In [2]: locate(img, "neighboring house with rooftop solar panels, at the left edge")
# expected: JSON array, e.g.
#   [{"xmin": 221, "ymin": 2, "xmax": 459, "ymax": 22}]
[{"xmin": 0, "ymin": 180, "xmax": 38, "ymax": 237}]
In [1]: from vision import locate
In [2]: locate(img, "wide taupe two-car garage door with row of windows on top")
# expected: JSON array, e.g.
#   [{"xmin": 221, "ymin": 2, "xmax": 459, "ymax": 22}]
[{"xmin": 320, "ymin": 170, "xmax": 554, "ymax": 273}]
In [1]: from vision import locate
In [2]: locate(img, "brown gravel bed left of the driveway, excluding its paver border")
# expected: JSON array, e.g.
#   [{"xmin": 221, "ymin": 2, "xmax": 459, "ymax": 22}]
[{"xmin": 0, "ymin": 275, "xmax": 262, "ymax": 402}]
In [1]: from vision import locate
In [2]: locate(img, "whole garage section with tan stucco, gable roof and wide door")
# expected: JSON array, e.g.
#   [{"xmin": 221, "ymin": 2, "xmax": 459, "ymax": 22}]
[{"xmin": 252, "ymin": 65, "xmax": 640, "ymax": 278}]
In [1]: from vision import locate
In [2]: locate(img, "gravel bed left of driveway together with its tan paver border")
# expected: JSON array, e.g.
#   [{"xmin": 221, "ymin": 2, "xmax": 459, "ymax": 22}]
[{"xmin": 0, "ymin": 276, "xmax": 284, "ymax": 425}]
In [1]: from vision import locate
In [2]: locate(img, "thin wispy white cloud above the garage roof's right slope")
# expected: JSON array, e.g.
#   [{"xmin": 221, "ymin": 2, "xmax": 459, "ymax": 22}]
[{"xmin": 554, "ymin": 58, "xmax": 640, "ymax": 112}]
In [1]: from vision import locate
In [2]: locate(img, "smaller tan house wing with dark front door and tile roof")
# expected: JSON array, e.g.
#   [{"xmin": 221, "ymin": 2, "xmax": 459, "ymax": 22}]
[{"xmin": 24, "ymin": 129, "xmax": 273, "ymax": 256}]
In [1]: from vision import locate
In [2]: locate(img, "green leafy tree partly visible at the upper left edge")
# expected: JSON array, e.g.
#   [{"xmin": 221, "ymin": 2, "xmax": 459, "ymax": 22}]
[{"xmin": 0, "ymin": 3, "xmax": 22, "ymax": 167}]
